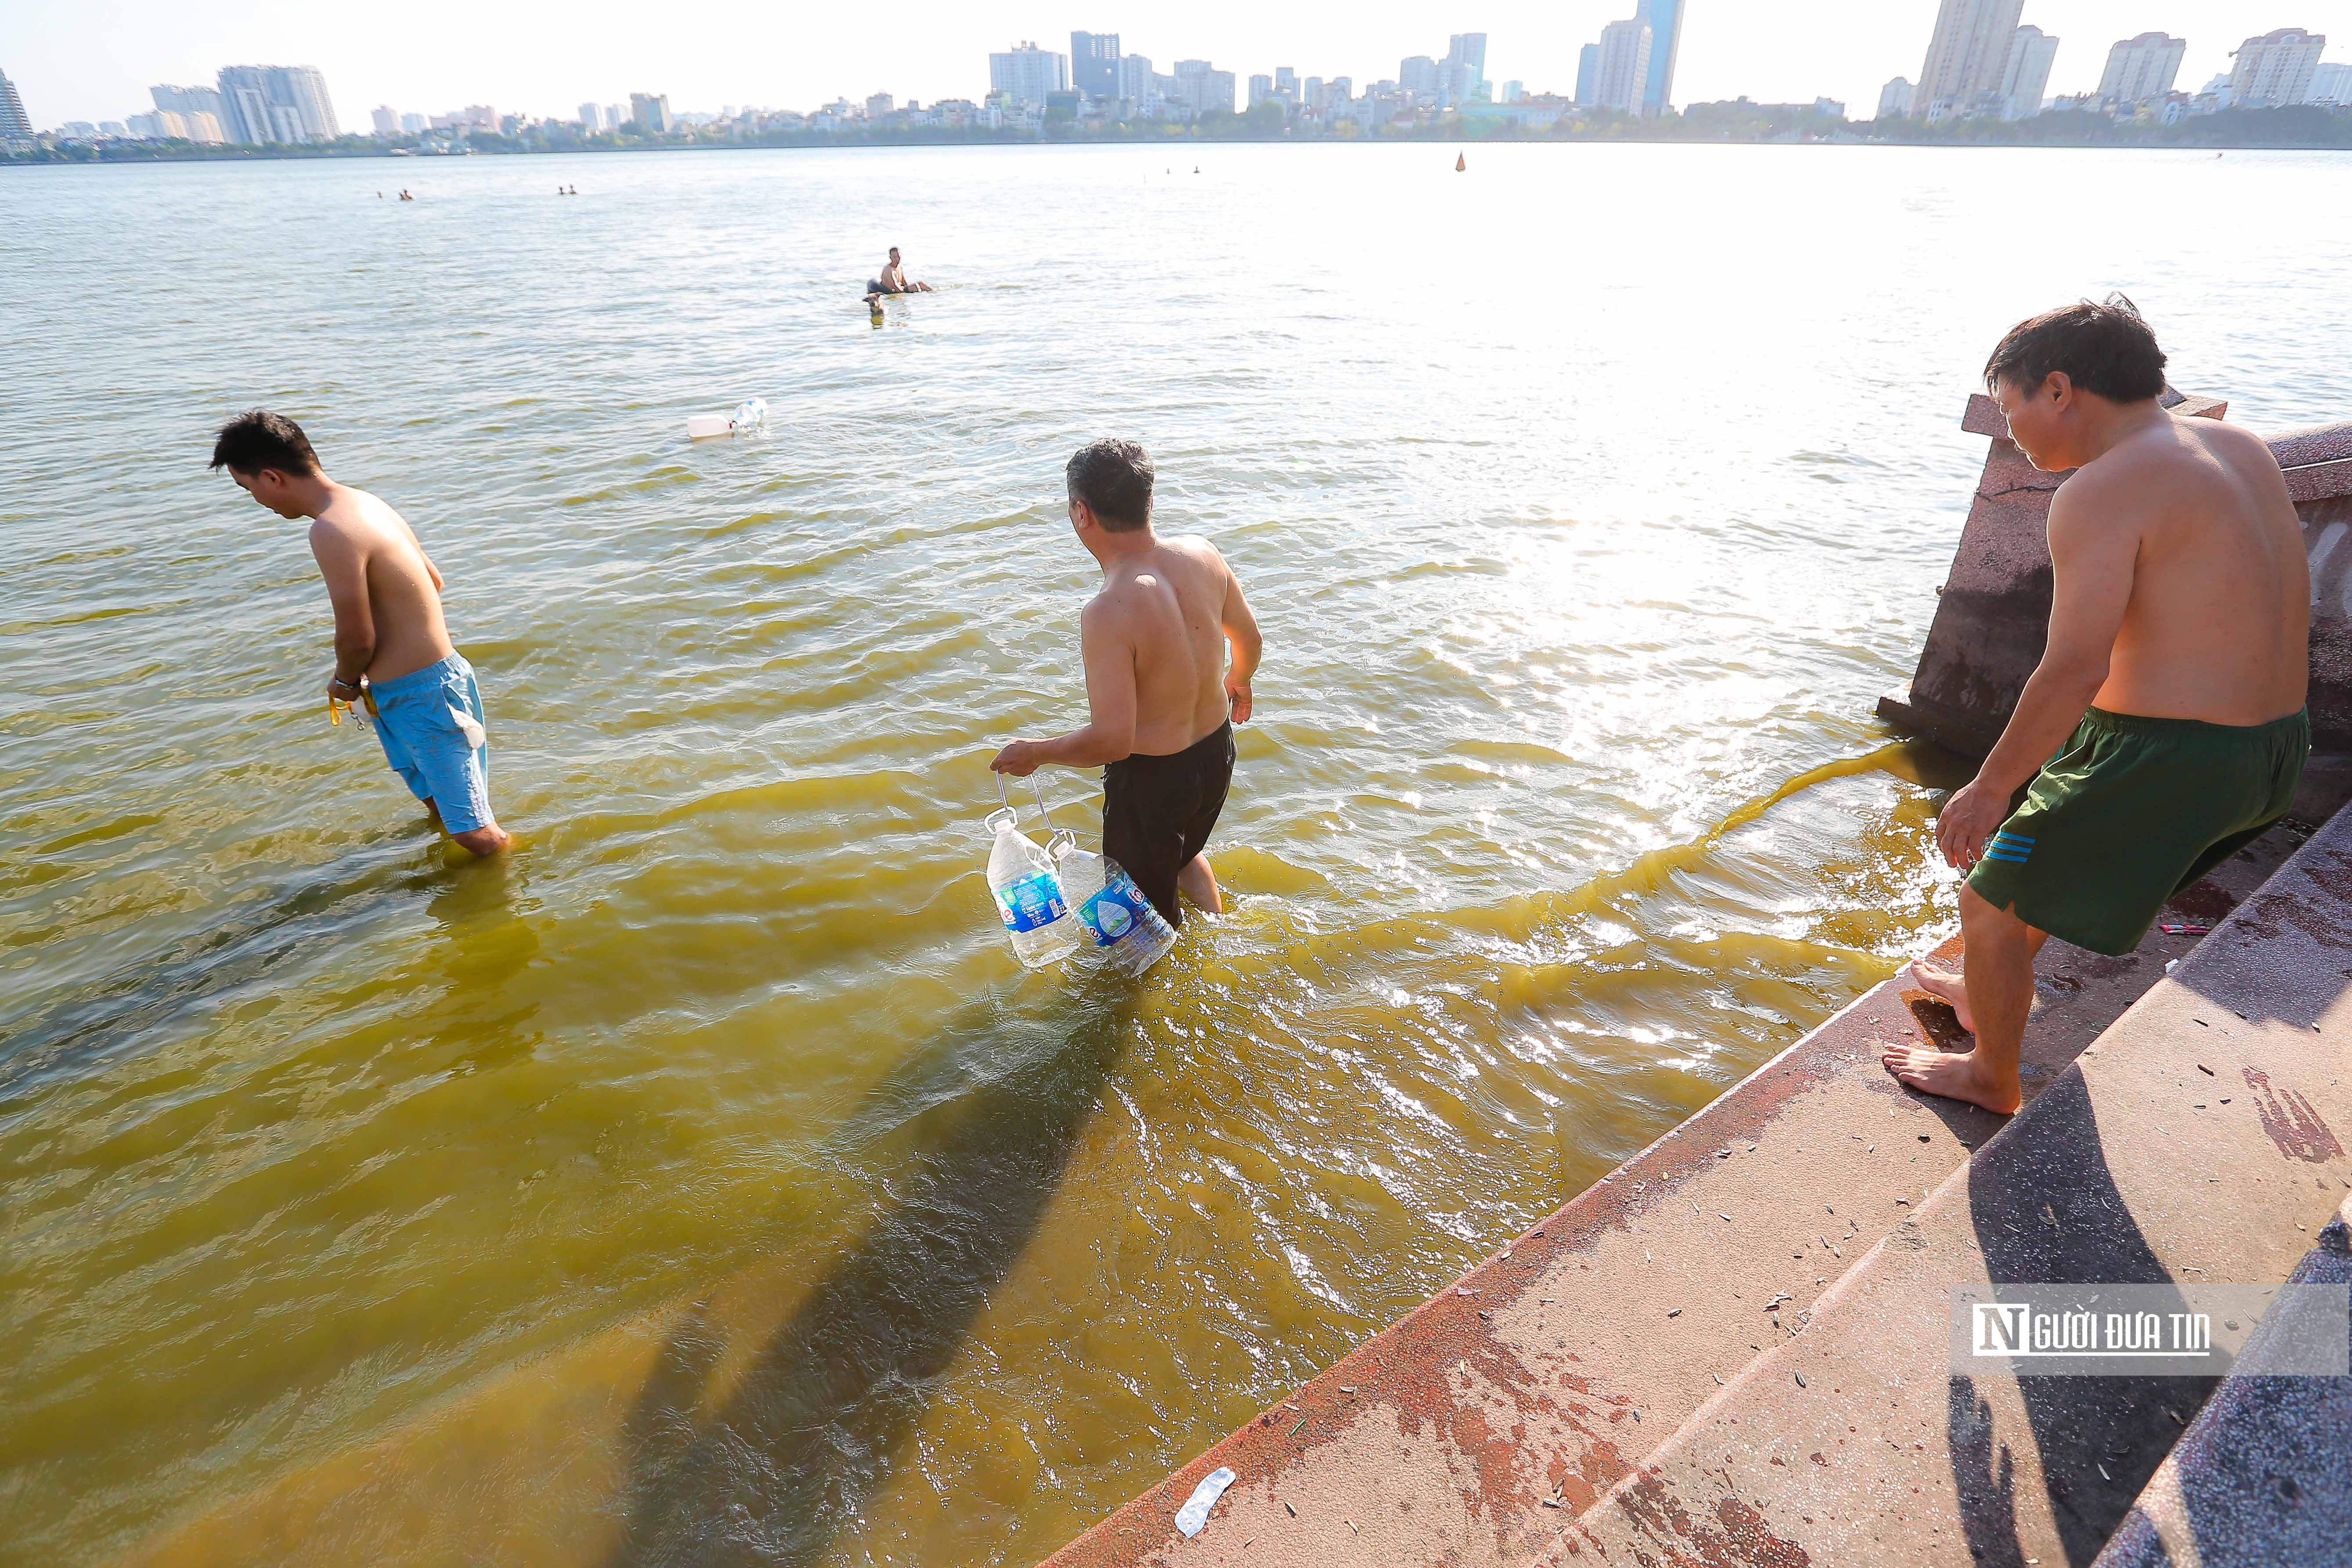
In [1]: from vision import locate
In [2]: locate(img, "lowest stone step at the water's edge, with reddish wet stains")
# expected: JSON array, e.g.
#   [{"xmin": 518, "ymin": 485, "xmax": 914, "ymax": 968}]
[{"xmin": 1049, "ymin": 795, "xmax": 2340, "ymax": 1568}]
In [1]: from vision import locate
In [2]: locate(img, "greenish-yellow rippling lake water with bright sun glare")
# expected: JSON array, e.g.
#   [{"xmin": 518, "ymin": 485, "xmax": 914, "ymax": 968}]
[{"xmin": 0, "ymin": 146, "xmax": 2352, "ymax": 1566}]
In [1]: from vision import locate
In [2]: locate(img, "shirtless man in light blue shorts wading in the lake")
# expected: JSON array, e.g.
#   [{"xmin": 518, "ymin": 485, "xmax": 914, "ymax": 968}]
[{"xmin": 212, "ymin": 409, "xmax": 513, "ymax": 856}]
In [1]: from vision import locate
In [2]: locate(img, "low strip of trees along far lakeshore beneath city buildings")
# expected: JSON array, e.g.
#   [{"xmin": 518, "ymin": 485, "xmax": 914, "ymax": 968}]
[{"xmin": 0, "ymin": 104, "xmax": 2352, "ymax": 167}]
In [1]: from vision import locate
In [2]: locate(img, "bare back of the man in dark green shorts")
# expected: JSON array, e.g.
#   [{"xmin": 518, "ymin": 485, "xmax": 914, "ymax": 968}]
[{"xmin": 2089, "ymin": 414, "xmax": 2312, "ymax": 724}]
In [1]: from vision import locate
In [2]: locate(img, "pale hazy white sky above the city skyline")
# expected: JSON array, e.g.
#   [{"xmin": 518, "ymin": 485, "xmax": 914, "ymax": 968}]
[{"xmin": 0, "ymin": 0, "xmax": 2352, "ymax": 129}]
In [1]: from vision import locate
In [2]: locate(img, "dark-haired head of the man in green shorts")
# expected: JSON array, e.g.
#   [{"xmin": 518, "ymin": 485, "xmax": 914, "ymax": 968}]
[{"xmin": 1985, "ymin": 294, "xmax": 2164, "ymax": 472}]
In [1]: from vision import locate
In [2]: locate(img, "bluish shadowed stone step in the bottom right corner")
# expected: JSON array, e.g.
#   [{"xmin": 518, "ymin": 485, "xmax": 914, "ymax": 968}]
[{"xmin": 2091, "ymin": 1197, "xmax": 2352, "ymax": 1568}]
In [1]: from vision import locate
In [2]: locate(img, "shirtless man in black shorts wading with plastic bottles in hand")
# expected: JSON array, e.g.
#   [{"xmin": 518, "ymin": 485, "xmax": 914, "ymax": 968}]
[{"xmin": 988, "ymin": 437, "xmax": 1261, "ymax": 926}]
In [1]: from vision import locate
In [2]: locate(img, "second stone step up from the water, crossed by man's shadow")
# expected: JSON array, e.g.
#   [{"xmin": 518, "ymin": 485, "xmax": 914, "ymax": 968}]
[{"xmin": 1531, "ymin": 799, "xmax": 2352, "ymax": 1566}]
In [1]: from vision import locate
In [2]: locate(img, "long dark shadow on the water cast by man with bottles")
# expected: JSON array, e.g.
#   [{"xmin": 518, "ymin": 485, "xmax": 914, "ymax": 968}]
[{"xmin": 604, "ymin": 973, "xmax": 1138, "ymax": 1568}]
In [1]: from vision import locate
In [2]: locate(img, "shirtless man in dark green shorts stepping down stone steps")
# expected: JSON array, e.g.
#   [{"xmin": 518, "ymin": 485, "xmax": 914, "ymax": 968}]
[{"xmin": 1882, "ymin": 296, "xmax": 2312, "ymax": 1114}]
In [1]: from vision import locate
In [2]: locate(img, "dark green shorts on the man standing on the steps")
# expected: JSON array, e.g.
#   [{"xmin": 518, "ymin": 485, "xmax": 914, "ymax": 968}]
[{"xmin": 1969, "ymin": 708, "xmax": 2312, "ymax": 957}]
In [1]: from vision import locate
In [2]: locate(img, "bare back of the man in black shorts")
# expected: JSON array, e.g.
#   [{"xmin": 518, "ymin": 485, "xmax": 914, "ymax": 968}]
[{"xmin": 1079, "ymin": 533, "xmax": 1249, "ymax": 757}]
